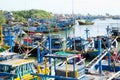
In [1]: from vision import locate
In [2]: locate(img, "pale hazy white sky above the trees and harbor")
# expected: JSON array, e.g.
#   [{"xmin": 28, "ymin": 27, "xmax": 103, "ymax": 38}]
[{"xmin": 0, "ymin": 0, "xmax": 120, "ymax": 15}]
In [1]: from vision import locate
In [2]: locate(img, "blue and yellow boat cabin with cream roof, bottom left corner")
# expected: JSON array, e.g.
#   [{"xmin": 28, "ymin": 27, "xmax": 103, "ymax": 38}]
[{"xmin": 0, "ymin": 59, "xmax": 35, "ymax": 80}]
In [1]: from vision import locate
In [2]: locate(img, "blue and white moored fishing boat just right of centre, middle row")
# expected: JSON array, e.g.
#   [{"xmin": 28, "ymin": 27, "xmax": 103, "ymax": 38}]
[{"xmin": 66, "ymin": 37, "xmax": 98, "ymax": 59}]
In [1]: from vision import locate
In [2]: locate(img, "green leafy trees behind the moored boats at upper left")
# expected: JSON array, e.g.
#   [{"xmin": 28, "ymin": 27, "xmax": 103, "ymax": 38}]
[{"xmin": 0, "ymin": 9, "xmax": 51, "ymax": 25}]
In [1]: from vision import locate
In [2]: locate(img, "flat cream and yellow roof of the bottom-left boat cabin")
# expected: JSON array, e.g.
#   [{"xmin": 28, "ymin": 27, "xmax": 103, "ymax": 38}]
[{"xmin": 0, "ymin": 58, "xmax": 34, "ymax": 67}]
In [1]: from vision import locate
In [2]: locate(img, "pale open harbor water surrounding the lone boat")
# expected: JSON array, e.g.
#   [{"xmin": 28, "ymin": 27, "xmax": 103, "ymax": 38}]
[{"xmin": 52, "ymin": 18, "xmax": 120, "ymax": 38}]
